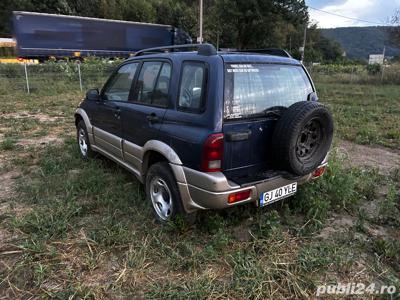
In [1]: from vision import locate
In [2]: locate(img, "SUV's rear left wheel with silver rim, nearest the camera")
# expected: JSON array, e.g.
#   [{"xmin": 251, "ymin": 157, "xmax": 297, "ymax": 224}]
[{"xmin": 146, "ymin": 162, "xmax": 193, "ymax": 223}]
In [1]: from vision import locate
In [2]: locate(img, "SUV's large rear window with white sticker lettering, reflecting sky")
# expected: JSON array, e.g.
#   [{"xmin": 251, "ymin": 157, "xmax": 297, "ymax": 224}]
[{"xmin": 224, "ymin": 64, "xmax": 313, "ymax": 119}]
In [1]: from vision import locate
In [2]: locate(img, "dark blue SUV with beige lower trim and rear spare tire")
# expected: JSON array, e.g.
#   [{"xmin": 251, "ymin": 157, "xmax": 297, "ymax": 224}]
[{"xmin": 75, "ymin": 44, "xmax": 333, "ymax": 221}]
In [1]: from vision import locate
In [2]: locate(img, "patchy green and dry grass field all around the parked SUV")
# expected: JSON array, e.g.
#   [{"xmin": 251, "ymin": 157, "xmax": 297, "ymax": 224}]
[{"xmin": 0, "ymin": 64, "xmax": 400, "ymax": 299}]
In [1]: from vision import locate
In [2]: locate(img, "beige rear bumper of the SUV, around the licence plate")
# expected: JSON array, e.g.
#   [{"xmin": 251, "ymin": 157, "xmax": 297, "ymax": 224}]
[{"xmin": 178, "ymin": 160, "xmax": 327, "ymax": 212}]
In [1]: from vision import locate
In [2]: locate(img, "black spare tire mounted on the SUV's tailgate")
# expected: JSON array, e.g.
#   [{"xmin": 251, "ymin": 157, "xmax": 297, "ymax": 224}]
[{"xmin": 272, "ymin": 101, "xmax": 333, "ymax": 175}]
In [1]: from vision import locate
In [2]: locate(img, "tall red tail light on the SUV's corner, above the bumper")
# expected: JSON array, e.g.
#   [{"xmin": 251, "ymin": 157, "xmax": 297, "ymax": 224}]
[{"xmin": 201, "ymin": 133, "xmax": 224, "ymax": 172}]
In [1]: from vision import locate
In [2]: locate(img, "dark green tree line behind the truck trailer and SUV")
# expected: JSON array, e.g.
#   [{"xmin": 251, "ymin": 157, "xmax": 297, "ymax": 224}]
[{"xmin": 0, "ymin": 0, "xmax": 343, "ymax": 61}]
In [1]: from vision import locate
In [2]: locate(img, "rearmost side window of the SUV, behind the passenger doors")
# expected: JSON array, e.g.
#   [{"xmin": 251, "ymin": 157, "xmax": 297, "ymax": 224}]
[{"xmin": 178, "ymin": 62, "xmax": 205, "ymax": 111}]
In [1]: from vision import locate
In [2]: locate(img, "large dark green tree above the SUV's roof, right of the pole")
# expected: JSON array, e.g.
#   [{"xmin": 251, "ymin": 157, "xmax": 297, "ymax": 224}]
[{"xmin": 210, "ymin": 0, "xmax": 308, "ymax": 49}]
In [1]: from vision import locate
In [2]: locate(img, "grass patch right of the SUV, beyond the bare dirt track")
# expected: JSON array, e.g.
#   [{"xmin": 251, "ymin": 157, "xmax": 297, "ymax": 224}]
[{"xmin": 316, "ymin": 74, "xmax": 400, "ymax": 149}]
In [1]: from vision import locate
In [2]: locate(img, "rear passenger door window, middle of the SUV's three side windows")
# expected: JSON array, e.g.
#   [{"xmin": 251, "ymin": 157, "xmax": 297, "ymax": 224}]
[{"xmin": 134, "ymin": 61, "xmax": 171, "ymax": 106}]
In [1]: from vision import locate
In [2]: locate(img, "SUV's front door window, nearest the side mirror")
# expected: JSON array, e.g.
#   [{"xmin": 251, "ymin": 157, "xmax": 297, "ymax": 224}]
[{"xmin": 103, "ymin": 63, "xmax": 139, "ymax": 101}]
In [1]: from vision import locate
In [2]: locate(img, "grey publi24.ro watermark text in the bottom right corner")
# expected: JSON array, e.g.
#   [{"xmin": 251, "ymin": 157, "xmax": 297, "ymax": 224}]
[{"xmin": 317, "ymin": 282, "xmax": 396, "ymax": 296}]
